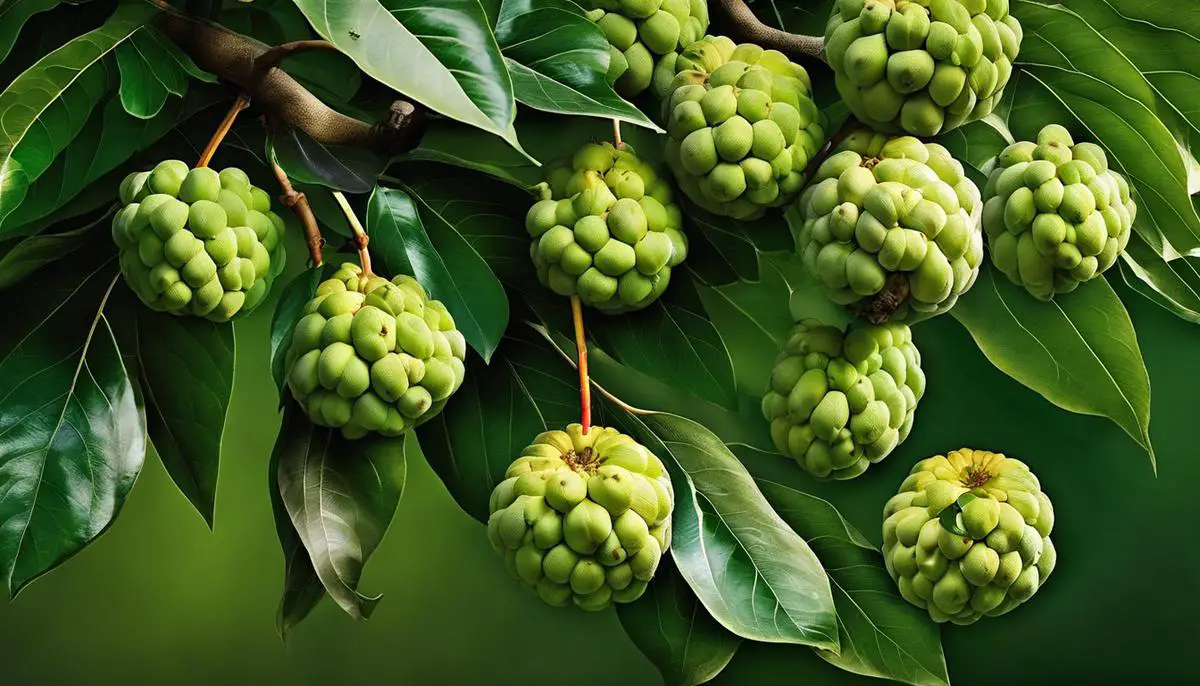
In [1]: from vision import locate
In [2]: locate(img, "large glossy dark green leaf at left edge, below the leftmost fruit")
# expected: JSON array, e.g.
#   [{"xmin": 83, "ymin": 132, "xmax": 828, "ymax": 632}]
[{"xmin": 0, "ymin": 249, "xmax": 146, "ymax": 596}]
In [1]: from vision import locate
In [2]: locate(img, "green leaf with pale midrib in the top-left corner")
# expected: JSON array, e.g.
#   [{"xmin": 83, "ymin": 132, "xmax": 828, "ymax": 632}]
[{"xmin": 0, "ymin": 2, "xmax": 157, "ymax": 231}]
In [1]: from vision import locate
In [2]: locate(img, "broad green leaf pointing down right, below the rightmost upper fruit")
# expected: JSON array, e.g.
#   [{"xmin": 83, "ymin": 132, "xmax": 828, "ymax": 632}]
[{"xmin": 950, "ymin": 265, "xmax": 1154, "ymax": 467}]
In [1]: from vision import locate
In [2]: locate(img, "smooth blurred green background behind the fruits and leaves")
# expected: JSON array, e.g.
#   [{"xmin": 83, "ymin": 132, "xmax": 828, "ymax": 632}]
[{"xmin": 0, "ymin": 253, "xmax": 1200, "ymax": 686}]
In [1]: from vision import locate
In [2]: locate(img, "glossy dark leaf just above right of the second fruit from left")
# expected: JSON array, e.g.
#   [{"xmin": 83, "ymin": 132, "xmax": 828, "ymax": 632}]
[{"xmin": 367, "ymin": 186, "xmax": 509, "ymax": 361}]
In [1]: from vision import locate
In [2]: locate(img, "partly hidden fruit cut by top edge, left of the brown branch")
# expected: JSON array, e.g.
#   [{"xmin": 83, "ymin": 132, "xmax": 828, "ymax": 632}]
[{"xmin": 581, "ymin": 0, "xmax": 708, "ymax": 97}]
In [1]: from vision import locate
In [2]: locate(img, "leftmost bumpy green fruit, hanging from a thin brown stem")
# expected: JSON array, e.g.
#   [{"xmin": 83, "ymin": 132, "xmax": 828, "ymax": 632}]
[{"xmin": 113, "ymin": 160, "xmax": 284, "ymax": 321}]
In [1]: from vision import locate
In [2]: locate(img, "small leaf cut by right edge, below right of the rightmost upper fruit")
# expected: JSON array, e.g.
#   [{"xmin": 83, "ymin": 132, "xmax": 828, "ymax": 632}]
[{"xmin": 1118, "ymin": 234, "xmax": 1200, "ymax": 324}]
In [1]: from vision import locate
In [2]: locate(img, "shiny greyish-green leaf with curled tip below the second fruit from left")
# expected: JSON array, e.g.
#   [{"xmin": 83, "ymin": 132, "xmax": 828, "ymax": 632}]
[{"xmin": 275, "ymin": 403, "xmax": 406, "ymax": 628}]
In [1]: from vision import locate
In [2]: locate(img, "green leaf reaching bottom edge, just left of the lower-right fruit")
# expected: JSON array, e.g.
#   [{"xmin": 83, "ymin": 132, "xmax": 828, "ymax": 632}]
[{"xmin": 737, "ymin": 447, "xmax": 950, "ymax": 686}]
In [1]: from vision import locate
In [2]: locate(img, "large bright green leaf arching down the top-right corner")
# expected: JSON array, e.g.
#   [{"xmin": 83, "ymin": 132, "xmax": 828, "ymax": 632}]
[{"xmin": 1008, "ymin": 0, "xmax": 1200, "ymax": 253}]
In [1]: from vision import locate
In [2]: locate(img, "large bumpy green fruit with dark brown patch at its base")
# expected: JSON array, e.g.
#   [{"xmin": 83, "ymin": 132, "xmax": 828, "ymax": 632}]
[{"xmin": 797, "ymin": 131, "xmax": 983, "ymax": 323}]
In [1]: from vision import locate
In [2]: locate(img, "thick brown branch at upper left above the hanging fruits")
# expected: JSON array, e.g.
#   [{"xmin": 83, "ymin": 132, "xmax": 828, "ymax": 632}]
[{"xmin": 156, "ymin": 8, "xmax": 425, "ymax": 155}]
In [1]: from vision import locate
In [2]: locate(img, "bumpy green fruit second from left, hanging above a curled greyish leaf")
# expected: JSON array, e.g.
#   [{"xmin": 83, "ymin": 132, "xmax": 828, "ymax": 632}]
[{"xmin": 284, "ymin": 264, "xmax": 467, "ymax": 439}]
